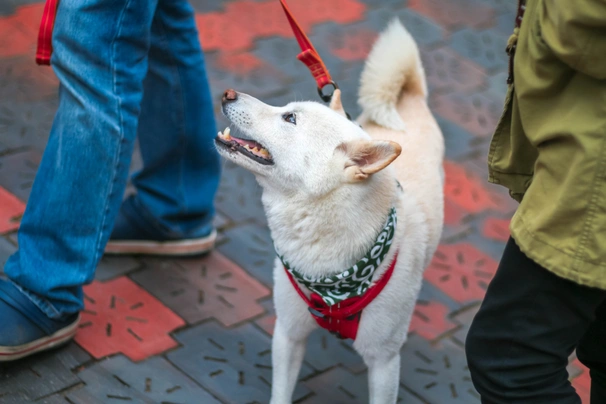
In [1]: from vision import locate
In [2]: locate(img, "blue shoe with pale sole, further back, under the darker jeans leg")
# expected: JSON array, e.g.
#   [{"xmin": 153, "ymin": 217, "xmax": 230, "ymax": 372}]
[{"xmin": 105, "ymin": 196, "xmax": 217, "ymax": 256}]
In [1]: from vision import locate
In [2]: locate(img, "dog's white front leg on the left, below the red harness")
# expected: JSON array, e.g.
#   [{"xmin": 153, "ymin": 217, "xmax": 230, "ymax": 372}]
[{"xmin": 271, "ymin": 318, "xmax": 307, "ymax": 404}]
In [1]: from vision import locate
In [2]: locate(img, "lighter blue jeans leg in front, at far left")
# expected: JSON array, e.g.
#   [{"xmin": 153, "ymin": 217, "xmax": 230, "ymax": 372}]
[{"xmin": 5, "ymin": 0, "xmax": 157, "ymax": 318}]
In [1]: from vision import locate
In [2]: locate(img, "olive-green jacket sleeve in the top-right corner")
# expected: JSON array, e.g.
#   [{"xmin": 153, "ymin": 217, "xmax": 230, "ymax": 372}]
[{"xmin": 539, "ymin": 0, "xmax": 606, "ymax": 80}]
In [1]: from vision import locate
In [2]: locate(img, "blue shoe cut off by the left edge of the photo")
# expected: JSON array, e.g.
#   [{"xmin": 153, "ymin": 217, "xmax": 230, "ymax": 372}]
[{"xmin": 0, "ymin": 279, "xmax": 80, "ymax": 362}]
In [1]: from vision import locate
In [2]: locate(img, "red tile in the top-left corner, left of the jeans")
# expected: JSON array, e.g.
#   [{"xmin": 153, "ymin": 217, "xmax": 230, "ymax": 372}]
[{"xmin": 0, "ymin": 3, "xmax": 44, "ymax": 58}]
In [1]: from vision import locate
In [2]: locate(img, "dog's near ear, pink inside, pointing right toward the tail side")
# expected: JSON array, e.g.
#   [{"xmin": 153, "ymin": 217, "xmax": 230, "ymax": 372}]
[{"xmin": 337, "ymin": 140, "xmax": 402, "ymax": 182}]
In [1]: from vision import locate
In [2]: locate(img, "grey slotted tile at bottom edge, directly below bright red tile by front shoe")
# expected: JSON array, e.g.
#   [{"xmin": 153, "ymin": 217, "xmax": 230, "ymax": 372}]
[{"xmin": 67, "ymin": 355, "xmax": 219, "ymax": 404}]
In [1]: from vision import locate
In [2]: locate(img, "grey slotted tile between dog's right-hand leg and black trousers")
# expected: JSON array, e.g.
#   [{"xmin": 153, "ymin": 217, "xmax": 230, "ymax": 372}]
[{"xmin": 401, "ymin": 336, "xmax": 480, "ymax": 404}]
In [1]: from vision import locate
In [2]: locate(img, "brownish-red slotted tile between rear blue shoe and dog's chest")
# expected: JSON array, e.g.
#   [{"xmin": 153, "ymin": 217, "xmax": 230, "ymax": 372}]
[{"xmin": 132, "ymin": 252, "xmax": 270, "ymax": 327}]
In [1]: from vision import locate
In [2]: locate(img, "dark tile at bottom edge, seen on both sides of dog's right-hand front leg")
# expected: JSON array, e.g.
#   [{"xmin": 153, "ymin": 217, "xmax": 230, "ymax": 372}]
[{"xmin": 301, "ymin": 367, "xmax": 425, "ymax": 404}]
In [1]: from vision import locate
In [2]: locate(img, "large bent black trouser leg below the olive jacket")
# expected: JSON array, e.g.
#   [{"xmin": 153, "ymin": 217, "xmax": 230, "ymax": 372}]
[{"xmin": 466, "ymin": 239, "xmax": 606, "ymax": 404}]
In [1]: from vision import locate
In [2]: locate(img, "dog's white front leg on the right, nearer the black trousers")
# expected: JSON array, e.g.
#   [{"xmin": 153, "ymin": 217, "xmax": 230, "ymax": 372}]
[{"xmin": 364, "ymin": 351, "xmax": 400, "ymax": 404}]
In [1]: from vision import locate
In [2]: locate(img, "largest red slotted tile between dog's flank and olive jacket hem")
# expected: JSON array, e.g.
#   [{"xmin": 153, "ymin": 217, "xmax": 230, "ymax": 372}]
[{"xmin": 424, "ymin": 243, "xmax": 498, "ymax": 302}]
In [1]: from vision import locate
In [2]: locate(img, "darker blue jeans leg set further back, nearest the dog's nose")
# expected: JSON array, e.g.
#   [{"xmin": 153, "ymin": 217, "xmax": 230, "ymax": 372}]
[{"xmin": 123, "ymin": 0, "xmax": 220, "ymax": 239}]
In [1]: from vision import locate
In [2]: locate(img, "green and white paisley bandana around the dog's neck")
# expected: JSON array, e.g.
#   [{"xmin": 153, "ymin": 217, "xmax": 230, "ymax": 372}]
[{"xmin": 278, "ymin": 208, "xmax": 397, "ymax": 306}]
